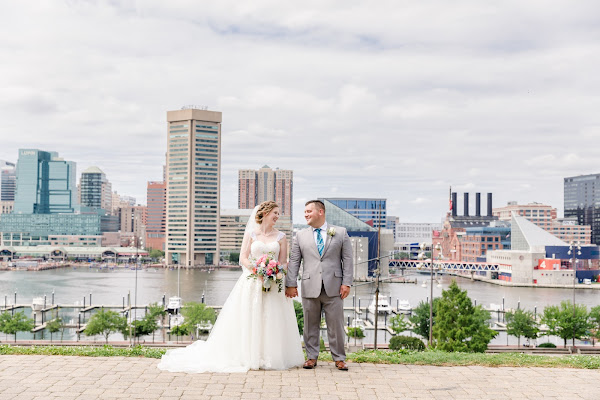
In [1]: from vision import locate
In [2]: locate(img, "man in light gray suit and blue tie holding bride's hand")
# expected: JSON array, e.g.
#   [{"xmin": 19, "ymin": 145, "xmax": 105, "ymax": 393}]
[{"xmin": 285, "ymin": 200, "xmax": 353, "ymax": 371}]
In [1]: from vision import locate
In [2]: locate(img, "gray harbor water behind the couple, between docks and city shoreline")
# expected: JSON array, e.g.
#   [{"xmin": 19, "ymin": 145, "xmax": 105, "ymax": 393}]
[{"xmin": 0, "ymin": 267, "xmax": 600, "ymax": 345}]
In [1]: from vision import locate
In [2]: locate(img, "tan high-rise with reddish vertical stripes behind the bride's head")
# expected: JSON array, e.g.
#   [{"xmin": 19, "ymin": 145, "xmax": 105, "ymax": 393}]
[{"xmin": 238, "ymin": 165, "xmax": 294, "ymax": 218}]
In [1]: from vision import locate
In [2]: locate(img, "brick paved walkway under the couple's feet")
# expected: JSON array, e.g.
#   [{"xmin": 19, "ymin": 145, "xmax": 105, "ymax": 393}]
[{"xmin": 0, "ymin": 356, "xmax": 600, "ymax": 400}]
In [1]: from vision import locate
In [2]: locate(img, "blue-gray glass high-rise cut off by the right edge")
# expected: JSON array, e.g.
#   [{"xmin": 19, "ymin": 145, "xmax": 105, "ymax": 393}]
[{"xmin": 564, "ymin": 174, "xmax": 600, "ymax": 245}]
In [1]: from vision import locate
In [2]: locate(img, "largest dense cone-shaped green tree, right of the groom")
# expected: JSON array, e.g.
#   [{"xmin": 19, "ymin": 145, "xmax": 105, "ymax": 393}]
[{"xmin": 433, "ymin": 280, "xmax": 498, "ymax": 353}]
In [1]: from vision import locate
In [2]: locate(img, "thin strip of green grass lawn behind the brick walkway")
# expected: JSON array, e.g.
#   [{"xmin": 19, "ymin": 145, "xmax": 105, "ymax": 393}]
[{"xmin": 0, "ymin": 345, "xmax": 600, "ymax": 369}]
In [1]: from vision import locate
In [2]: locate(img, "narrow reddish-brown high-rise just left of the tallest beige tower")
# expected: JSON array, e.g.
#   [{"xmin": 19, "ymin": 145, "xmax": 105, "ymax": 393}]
[{"xmin": 146, "ymin": 182, "xmax": 167, "ymax": 251}]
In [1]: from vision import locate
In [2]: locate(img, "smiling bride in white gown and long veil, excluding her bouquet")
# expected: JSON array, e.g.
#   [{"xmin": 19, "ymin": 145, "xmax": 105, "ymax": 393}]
[{"xmin": 158, "ymin": 201, "xmax": 304, "ymax": 373}]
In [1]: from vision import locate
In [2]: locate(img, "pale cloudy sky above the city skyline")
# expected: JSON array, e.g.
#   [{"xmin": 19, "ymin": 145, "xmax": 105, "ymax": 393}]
[{"xmin": 0, "ymin": 0, "xmax": 600, "ymax": 222}]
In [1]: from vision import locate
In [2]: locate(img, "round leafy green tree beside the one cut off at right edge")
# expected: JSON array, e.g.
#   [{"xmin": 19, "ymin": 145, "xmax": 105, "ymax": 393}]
[{"xmin": 542, "ymin": 300, "xmax": 590, "ymax": 347}]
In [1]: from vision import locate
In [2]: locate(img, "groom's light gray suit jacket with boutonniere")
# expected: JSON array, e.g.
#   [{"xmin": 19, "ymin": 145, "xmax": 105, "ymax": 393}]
[{"xmin": 285, "ymin": 225, "xmax": 354, "ymax": 299}]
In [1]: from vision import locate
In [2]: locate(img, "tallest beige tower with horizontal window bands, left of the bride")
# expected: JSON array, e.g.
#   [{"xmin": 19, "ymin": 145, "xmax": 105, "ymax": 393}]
[{"xmin": 165, "ymin": 108, "xmax": 222, "ymax": 266}]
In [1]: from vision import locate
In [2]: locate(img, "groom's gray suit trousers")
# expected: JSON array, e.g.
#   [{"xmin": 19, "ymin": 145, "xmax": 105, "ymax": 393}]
[{"xmin": 302, "ymin": 287, "xmax": 346, "ymax": 361}]
